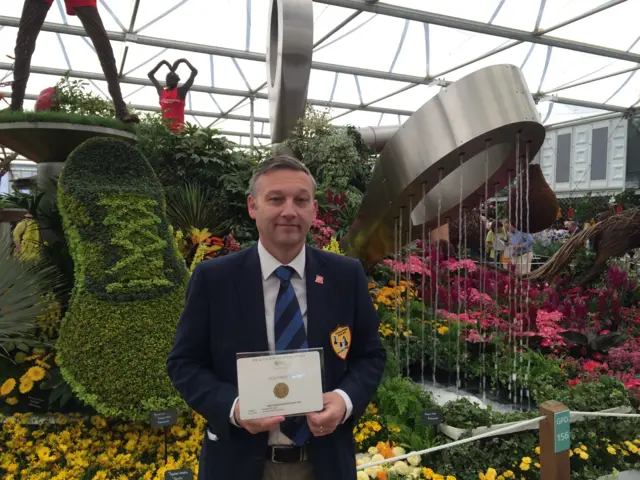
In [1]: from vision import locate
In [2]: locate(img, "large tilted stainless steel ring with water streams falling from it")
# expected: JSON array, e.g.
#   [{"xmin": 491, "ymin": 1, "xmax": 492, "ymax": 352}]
[{"xmin": 341, "ymin": 65, "xmax": 545, "ymax": 265}]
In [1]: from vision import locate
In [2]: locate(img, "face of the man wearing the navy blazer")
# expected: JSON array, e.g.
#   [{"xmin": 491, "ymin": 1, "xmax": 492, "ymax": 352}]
[{"xmin": 247, "ymin": 170, "xmax": 318, "ymax": 249}]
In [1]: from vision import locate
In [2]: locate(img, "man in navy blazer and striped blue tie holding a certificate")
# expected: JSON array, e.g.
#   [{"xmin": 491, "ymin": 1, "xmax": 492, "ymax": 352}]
[{"xmin": 167, "ymin": 156, "xmax": 386, "ymax": 480}]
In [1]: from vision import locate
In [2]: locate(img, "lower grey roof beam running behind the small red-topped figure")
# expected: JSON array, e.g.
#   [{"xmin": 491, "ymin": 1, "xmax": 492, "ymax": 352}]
[{"xmin": 0, "ymin": 62, "xmax": 413, "ymax": 116}]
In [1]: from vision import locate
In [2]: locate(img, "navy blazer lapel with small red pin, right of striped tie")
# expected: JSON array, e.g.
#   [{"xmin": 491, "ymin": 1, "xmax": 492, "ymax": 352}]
[{"xmin": 305, "ymin": 246, "xmax": 329, "ymax": 348}]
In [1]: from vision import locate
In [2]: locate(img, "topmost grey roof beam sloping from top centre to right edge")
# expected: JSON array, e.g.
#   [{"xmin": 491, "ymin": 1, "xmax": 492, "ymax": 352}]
[{"xmin": 314, "ymin": 0, "xmax": 640, "ymax": 63}]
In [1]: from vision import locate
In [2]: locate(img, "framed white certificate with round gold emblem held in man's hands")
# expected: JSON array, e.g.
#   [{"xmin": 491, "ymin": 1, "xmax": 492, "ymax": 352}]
[{"xmin": 236, "ymin": 348, "xmax": 323, "ymax": 420}]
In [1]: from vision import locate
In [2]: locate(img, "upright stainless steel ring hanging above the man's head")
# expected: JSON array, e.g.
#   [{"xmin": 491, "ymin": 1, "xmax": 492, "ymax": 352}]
[{"xmin": 267, "ymin": 0, "xmax": 313, "ymax": 146}]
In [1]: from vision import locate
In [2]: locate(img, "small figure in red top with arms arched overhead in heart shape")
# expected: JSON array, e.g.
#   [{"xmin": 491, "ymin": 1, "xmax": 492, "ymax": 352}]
[{"xmin": 148, "ymin": 58, "xmax": 198, "ymax": 132}]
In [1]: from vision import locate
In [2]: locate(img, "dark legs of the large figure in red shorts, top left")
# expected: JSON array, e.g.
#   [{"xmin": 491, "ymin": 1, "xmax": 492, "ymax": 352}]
[{"xmin": 6, "ymin": 0, "xmax": 139, "ymax": 123}]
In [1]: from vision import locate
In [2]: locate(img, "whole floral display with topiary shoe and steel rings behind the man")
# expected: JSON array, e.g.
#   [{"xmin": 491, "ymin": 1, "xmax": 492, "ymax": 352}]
[{"xmin": 0, "ymin": 0, "xmax": 640, "ymax": 480}]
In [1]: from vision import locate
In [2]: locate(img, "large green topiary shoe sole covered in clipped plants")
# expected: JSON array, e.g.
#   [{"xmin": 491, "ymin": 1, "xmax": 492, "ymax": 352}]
[{"xmin": 57, "ymin": 138, "xmax": 188, "ymax": 420}]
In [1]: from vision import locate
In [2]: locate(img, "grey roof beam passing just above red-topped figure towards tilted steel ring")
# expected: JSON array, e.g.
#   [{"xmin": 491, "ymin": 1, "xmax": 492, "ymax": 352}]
[{"xmin": 0, "ymin": 15, "xmax": 430, "ymax": 83}]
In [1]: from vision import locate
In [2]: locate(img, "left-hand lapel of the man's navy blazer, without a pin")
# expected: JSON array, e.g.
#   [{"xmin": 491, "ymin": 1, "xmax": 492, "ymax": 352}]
[{"xmin": 236, "ymin": 244, "xmax": 269, "ymax": 352}]
